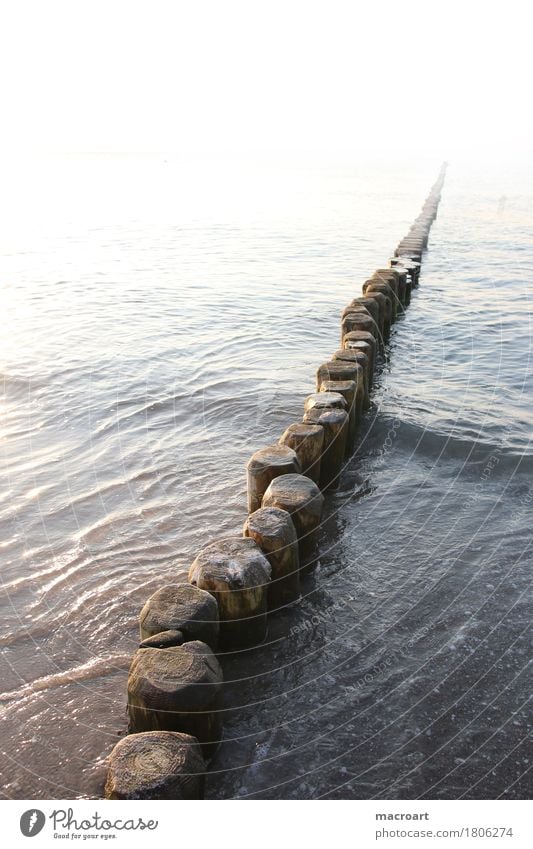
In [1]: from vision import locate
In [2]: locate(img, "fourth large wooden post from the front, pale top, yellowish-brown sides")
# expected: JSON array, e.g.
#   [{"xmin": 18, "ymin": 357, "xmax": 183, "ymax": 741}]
[{"xmin": 189, "ymin": 536, "xmax": 272, "ymax": 650}]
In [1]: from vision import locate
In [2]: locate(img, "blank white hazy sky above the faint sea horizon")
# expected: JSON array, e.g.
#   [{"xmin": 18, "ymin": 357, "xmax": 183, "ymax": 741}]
[{"xmin": 0, "ymin": 0, "xmax": 533, "ymax": 164}]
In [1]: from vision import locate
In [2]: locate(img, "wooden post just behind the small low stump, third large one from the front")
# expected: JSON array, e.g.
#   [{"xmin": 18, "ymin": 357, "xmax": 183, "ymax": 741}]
[{"xmin": 139, "ymin": 584, "xmax": 219, "ymax": 651}]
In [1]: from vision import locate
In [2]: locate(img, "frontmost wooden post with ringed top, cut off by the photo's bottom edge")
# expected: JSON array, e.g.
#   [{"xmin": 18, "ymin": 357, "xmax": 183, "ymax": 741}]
[{"xmin": 104, "ymin": 731, "xmax": 206, "ymax": 800}]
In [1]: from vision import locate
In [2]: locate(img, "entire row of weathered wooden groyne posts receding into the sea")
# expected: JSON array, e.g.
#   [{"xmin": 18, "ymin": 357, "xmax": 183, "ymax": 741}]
[{"xmin": 101, "ymin": 164, "xmax": 446, "ymax": 799}]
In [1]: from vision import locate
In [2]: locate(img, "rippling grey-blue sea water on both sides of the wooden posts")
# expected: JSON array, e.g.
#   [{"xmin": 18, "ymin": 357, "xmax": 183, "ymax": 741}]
[{"xmin": 0, "ymin": 157, "xmax": 533, "ymax": 799}]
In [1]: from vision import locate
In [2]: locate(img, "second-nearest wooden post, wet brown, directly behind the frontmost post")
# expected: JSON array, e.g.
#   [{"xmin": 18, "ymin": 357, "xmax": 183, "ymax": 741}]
[{"xmin": 128, "ymin": 640, "xmax": 222, "ymax": 755}]
